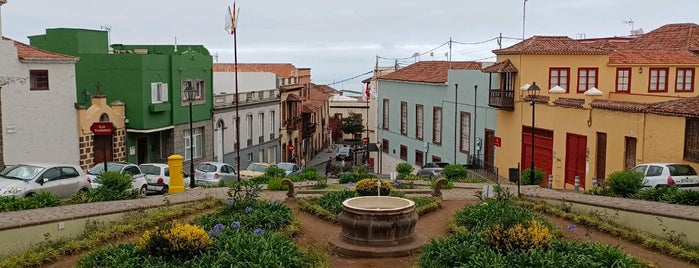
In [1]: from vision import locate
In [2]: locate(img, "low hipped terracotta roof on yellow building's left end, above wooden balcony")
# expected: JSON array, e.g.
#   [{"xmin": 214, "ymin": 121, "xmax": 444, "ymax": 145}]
[{"xmin": 493, "ymin": 36, "xmax": 609, "ymax": 55}]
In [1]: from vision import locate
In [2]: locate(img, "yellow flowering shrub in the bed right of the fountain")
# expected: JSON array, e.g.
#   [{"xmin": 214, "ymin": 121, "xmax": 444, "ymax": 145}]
[{"xmin": 485, "ymin": 220, "xmax": 553, "ymax": 253}]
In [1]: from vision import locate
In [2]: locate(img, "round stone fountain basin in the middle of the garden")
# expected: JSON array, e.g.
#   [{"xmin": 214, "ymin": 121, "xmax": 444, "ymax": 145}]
[{"xmin": 330, "ymin": 196, "xmax": 426, "ymax": 257}]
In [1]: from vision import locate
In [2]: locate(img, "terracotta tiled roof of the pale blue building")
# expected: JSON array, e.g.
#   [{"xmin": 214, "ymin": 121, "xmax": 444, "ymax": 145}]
[{"xmin": 378, "ymin": 61, "xmax": 481, "ymax": 83}]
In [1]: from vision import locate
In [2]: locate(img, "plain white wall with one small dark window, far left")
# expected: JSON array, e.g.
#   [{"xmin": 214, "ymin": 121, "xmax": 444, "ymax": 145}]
[{"xmin": 0, "ymin": 44, "xmax": 79, "ymax": 165}]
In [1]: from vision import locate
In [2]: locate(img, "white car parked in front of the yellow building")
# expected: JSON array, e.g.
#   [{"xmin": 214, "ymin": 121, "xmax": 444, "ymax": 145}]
[{"xmin": 631, "ymin": 163, "xmax": 699, "ymax": 187}]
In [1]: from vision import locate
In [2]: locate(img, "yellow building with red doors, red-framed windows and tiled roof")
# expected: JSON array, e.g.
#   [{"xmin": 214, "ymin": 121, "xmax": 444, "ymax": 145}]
[{"xmin": 484, "ymin": 23, "xmax": 699, "ymax": 189}]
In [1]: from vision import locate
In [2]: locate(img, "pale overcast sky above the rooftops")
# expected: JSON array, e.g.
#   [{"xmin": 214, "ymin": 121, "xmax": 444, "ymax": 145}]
[{"xmin": 2, "ymin": 0, "xmax": 699, "ymax": 90}]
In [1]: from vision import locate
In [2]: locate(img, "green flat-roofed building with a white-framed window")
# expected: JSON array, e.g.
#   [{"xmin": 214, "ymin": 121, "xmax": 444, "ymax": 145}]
[{"xmin": 29, "ymin": 28, "xmax": 213, "ymax": 165}]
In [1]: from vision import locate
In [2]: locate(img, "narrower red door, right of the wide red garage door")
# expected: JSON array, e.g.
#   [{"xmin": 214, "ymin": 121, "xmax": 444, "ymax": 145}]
[{"xmin": 565, "ymin": 133, "xmax": 587, "ymax": 188}]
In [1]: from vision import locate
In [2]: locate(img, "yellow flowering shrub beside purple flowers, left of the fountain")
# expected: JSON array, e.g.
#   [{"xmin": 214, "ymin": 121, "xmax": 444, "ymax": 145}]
[{"xmin": 136, "ymin": 222, "xmax": 213, "ymax": 258}]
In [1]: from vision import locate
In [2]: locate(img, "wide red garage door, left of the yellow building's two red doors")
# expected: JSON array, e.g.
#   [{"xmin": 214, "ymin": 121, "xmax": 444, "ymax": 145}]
[{"xmin": 522, "ymin": 126, "xmax": 553, "ymax": 187}]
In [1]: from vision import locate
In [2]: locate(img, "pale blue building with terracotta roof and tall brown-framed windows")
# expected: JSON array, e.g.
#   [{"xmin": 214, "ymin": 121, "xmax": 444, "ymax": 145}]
[{"xmin": 377, "ymin": 61, "xmax": 496, "ymax": 173}]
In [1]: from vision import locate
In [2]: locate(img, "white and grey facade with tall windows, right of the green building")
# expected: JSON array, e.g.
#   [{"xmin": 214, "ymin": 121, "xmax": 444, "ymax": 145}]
[{"xmin": 213, "ymin": 68, "xmax": 280, "ymax": 168}]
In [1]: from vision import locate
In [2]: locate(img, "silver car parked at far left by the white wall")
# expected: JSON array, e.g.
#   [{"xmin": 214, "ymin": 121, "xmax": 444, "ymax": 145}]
[{"xmin": 0, "ymin": 163, "xmax": 92, "ymax": 199}]
